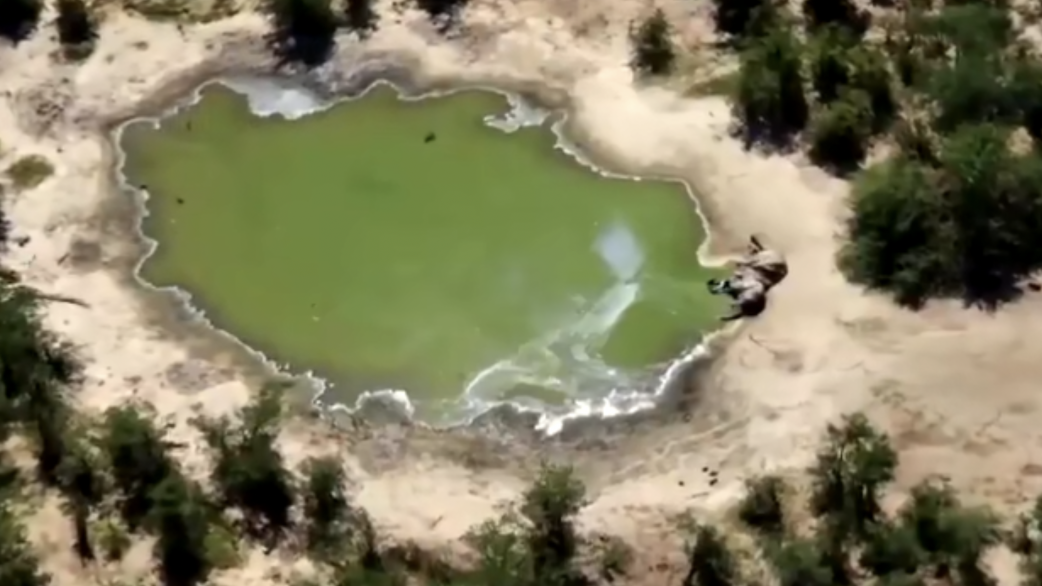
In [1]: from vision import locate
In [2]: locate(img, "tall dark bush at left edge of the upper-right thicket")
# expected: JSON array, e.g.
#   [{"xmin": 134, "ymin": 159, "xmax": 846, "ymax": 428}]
[{"xmin": 734, "ymin": 26, "xmax": 810, "ymax": 146}]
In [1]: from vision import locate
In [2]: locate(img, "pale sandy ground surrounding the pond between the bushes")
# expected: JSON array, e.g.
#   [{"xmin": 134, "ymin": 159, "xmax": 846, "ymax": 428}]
[{"xmin": 6, "ymin": 0, "xmax": 1042, "ymax": 584}]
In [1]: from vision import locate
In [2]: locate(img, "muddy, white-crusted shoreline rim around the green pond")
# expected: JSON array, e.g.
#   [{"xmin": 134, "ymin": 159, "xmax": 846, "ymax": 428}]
[{"xmin": 107, "ymin": 52, "xmax": 725, "ymax": 438}]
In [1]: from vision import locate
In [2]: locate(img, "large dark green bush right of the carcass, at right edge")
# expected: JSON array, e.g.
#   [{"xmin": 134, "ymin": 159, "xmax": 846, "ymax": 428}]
[{"xmin": 841, "ymin": 125, "xmax": 1042, "ymax": 306}]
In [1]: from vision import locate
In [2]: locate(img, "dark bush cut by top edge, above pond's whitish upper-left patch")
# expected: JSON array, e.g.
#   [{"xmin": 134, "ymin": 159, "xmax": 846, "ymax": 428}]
[{"xmin": 267, "ymin": 0, "xmax": 338, "ymax": 68}]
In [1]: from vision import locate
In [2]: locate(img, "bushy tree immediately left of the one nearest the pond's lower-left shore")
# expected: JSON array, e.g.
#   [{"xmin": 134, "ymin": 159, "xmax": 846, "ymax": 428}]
[{"xmin": 97, "ymin": 406, "xmax": 176, "ymax": 529}]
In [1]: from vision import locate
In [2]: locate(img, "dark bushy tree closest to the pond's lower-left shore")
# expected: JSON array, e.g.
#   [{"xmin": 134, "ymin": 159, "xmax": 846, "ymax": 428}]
[{"xmin": 197, "ymin": 387, "xmax": 296, "ymax": 544}]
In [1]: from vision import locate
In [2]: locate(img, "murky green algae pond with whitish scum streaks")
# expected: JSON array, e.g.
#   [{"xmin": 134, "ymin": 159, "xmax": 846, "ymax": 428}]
[{"xmin": 121, "ymin": 79, "xmax": 723, "ymax": 422}]
